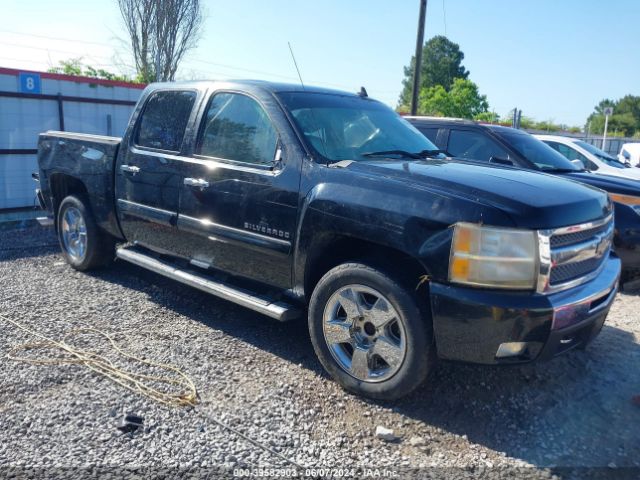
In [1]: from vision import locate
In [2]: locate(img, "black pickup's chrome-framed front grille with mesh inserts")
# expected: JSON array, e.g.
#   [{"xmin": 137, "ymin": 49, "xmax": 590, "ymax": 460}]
[{"xmin": 538, "ymin": 215, "xmax": 613, "ymax": 293}]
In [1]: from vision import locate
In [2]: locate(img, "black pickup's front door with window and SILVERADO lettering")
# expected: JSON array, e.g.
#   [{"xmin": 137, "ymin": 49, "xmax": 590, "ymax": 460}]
[{"xmin": 178, "ymin": 91, "xmax": 302, "ymax": 288}]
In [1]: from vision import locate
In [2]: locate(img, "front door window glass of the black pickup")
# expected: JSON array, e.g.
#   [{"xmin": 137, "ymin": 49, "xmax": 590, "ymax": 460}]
[{"xmin": 196, "ymin": 93, "xmax": 278, "ymax": 165}]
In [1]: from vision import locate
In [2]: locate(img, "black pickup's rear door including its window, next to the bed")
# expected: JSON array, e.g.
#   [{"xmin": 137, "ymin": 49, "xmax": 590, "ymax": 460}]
[{"xmin": 115, "ymin": 89, "xmax": 198, "ymax": 253}]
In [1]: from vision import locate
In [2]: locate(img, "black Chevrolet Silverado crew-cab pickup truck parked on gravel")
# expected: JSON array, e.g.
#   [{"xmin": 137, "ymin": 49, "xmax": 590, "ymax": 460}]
[{"xmin": 38, "ymin": 81, "xmax": 620, "ymax": 399}]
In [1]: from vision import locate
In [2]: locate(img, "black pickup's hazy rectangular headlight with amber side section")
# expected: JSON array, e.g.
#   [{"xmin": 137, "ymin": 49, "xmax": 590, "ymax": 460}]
[{"xmin": 449, "ymin": 223, "xmax": 538, "ymax": 289}]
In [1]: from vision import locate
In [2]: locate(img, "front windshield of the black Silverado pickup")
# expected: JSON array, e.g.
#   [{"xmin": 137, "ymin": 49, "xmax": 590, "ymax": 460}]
[{"xmin": 278, "ymin": 92, "xmax": 444, "ymax": 162}]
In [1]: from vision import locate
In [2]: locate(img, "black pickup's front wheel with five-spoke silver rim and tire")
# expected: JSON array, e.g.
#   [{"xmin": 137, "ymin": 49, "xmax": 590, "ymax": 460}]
[{"xmin": 309, "ymin": 263, "xmax": 435, "ymax": 400}]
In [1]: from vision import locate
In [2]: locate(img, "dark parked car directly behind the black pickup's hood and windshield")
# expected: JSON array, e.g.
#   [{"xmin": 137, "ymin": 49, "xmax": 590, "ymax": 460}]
[{"xmin": 406, "ymin": 117, "xmax": 640, "ymax": 278}]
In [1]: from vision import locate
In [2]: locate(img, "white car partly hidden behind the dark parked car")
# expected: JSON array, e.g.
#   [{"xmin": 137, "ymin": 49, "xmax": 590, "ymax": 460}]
[{"xmin": 534, "ymin": 135, "xmax": 640, "ymax": 180}]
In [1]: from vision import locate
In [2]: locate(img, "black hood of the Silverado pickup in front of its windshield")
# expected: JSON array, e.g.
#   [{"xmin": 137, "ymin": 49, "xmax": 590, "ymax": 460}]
[{"xmin": 348, "ymin": 159, "xmax": 611, "ymax": 229}]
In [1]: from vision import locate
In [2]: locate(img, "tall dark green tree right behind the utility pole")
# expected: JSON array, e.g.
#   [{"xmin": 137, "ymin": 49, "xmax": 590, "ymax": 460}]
[{"xmin": 398, "ymin": 35, "xmax": 469, "ymax": 109}]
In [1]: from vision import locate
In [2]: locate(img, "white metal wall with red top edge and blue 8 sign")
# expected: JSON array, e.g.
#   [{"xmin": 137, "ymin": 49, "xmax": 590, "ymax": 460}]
[{"xmin": 0, "ymin": 67, "xmax": 145, "ymax": 210}]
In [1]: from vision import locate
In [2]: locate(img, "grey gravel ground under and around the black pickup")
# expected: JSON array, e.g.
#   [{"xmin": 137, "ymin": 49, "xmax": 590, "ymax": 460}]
[{"xmin": 0, "ymin": 223, "xmax": 640, "ymax": 478}]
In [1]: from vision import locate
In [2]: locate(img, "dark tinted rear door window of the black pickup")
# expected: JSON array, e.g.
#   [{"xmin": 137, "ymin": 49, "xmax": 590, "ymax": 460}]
[{"xmin": 135, "ymin": 90, "xmax": 196, "ymax": 152}]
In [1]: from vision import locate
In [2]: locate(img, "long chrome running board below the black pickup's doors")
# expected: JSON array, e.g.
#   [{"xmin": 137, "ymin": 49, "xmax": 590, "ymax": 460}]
[{"xmin": 116, "ymin": 247, "xmax": 300, "ymax": 322}]
